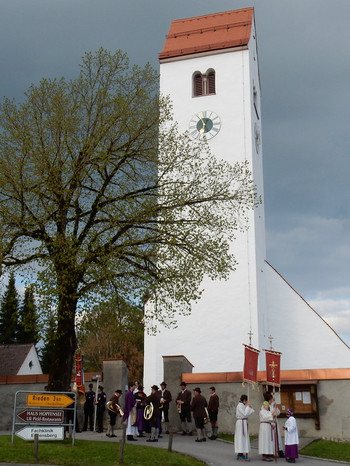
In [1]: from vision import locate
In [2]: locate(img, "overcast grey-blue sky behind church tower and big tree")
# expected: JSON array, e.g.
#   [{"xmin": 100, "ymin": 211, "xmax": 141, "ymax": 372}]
[{"xmin": 0, "ymin": 0, "xmax": 350, "ymax": 345}]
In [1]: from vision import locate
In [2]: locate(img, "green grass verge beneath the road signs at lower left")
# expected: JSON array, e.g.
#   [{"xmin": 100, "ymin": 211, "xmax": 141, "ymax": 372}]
[{"xmin": 0, "ymin": 435, "xmax": 204, "ymax": 466}]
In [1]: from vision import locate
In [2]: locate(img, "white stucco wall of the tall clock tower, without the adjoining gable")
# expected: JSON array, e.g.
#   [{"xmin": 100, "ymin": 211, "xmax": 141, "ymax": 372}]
[{"xmin": 144, "ymin": 19, "xmax": 265, "ymax": 387}]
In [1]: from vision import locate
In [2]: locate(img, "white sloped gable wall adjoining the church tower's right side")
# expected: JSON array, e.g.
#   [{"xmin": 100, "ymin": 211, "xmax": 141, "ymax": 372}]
[{"xmin": 264, "ymin": 264, "xmax": 350, "ymax": 370}]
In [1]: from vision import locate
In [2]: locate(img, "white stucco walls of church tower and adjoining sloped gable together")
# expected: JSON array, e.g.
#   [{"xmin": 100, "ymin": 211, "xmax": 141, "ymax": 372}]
[{"xmin": 144, "ymin": 12, "xmax": 350, "ymax": 387}]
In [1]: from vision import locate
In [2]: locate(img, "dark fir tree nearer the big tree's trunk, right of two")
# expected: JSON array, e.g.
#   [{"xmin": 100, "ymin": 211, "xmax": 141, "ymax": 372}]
[{"xmin": 17, "ymin": 286, "xmax": 39, "ymax": 344}]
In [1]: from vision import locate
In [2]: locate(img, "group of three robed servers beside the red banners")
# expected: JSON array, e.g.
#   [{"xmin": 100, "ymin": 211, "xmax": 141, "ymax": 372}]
[{"xmin": 234, "ymin": 393, "xmax": 299, "ymax": 463}]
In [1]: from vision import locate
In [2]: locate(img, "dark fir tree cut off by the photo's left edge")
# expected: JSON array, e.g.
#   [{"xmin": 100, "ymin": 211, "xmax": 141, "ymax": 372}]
[{"xmin": 0, "ymin": 273, "xmax": 19, "ymax": 345}]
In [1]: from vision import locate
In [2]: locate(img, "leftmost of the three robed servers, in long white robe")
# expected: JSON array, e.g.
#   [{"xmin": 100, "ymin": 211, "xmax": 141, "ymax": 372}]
[{"xmin": 235, "ymin": 395, "xmax": 254, "ymax": 461}]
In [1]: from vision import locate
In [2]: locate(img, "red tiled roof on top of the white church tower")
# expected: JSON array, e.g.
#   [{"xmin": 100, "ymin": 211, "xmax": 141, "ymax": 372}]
[{"xmin": 159, "ymin": 8, "xmax": 254, "ymax": 60}]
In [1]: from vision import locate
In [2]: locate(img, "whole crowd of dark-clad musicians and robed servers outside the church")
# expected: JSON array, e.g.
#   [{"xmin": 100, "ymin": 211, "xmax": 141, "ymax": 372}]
[{"xmin": 78, "ymin": 381, "xmax": 299, "ymax": 463}]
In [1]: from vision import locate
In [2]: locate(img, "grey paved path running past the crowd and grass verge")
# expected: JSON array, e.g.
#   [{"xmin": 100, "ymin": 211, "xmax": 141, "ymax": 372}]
[{"xmin": 0, "ymin": 430, "xmax": 349, "ymax": 466}]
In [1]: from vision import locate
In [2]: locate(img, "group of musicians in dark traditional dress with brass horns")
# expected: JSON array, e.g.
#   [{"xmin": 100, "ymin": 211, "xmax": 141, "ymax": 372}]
[{"xmin": 77, "ymin": 381, "xmax": 219, "ymax": 442}]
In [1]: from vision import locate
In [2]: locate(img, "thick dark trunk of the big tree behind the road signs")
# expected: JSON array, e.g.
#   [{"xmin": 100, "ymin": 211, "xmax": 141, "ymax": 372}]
[{"xmin": 48, "ymin": 293, "xmax": 77, "ymax": 391}]
